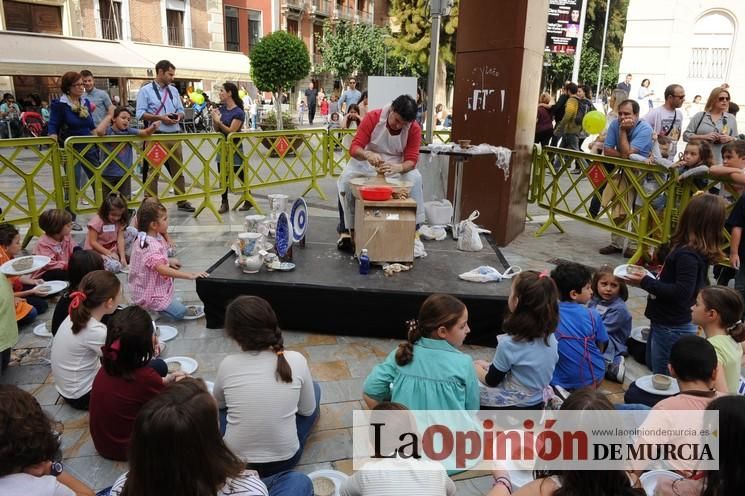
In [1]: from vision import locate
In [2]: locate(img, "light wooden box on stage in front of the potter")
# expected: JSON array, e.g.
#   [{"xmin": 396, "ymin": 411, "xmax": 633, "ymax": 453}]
[{"xmin": 354, "ymin": 198, "xmax": 416, "ymax": 262}]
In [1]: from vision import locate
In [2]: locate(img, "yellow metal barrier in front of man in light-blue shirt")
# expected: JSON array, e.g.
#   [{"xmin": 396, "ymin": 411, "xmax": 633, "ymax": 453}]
[{"xmin": 64, "ymin": 133, "xmax": 226, "ymax": 219}]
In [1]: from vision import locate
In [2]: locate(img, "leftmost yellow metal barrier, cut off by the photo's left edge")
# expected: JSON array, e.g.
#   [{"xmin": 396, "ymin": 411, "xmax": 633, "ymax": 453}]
[{"xmin": 0, "ymin": 138, "xmax": 64, "ymax": 246}]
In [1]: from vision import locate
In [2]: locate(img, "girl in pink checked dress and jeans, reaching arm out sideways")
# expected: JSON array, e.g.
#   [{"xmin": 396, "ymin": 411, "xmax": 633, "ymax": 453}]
[{"xmin": 129, "ymin": 202, "xmax": 209, "ymax": 320}]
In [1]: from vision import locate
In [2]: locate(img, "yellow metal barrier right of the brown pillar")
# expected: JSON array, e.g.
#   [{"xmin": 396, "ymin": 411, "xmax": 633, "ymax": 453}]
[{"xmin": 528, "ymin": 147, "xmax": 740, "ymax": 263}]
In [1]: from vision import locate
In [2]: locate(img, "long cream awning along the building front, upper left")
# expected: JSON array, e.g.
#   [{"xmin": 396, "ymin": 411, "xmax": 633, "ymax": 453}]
[{"xmin": 0, "ymin": 31, "xmax": 249, "ymax": 81}]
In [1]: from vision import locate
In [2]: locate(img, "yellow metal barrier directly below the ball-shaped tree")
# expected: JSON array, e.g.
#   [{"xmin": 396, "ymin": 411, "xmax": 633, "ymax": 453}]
[{"xmin": 222, "ymin": 129, "xmax": 328, "ymax": 213}]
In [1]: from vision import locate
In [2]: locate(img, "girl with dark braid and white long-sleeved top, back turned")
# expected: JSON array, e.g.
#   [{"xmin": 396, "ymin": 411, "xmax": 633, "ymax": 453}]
[{"xmin": 213, "ymin": 296, "xmax": 321, "ymax": 478}]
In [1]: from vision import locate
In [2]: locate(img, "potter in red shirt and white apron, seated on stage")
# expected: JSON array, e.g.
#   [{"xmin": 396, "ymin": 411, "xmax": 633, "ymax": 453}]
[{"xmin": 336, "ymin": 95, "xmax": 424, "ymax": 252}]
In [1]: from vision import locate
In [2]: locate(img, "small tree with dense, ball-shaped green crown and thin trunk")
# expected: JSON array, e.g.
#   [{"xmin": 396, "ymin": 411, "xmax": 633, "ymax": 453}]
[{"xmin": 250, "ymin": 31, "xmax": 310, "ymax": 129}]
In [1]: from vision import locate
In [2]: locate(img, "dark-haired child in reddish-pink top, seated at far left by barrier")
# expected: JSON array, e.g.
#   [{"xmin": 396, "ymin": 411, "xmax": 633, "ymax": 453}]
[{"xmin": 33, "ymin": 208, "xmax": 77, "ymax": 281}]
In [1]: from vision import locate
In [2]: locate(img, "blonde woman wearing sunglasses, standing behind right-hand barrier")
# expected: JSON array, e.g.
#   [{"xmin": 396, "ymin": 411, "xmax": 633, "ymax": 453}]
[{"xmin": 683, "ymin": 86, "xmax": 738, "ymax": 164}]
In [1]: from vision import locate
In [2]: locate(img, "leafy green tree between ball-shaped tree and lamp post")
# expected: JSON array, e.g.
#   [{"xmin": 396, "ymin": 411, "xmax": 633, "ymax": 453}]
[{"xmin": 318, "ymin": 21, "xmax": 388, "ymax": 80}]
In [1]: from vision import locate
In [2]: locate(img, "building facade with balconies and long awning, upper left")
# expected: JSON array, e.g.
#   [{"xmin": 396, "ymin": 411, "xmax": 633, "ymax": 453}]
[{"xmin": 0, "ymin": 0, "xmax": 250, "ymax": 101}]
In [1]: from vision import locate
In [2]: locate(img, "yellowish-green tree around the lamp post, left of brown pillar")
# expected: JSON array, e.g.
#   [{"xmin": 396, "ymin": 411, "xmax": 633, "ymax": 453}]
[{"xmin": 389, "ymin": 0, "xmax": 460, "ymax": 107}]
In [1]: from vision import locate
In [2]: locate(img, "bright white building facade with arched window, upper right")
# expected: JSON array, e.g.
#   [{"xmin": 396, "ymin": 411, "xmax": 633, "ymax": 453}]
[{"xmin": 619, "ymin": 0, "xmax": 745, "ymax": 129}]
